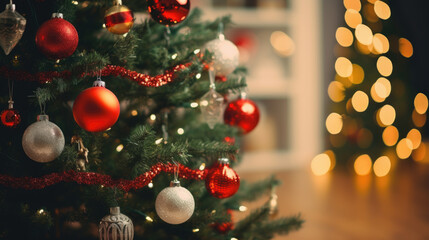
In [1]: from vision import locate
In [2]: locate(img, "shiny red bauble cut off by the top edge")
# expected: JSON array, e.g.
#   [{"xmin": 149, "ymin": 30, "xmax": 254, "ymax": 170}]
[{"xmin": 147, "ymin": 0, "xmax": 191, "ymax": 26}]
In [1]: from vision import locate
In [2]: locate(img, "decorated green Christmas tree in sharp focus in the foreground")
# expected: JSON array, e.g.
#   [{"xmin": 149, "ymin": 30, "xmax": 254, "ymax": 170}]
[{"xmin": 0, "ymin": 0, "xmax": 303, "ymax": 240}]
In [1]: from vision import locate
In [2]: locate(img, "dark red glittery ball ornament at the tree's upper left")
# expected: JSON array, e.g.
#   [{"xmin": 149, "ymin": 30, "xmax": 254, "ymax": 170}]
[{"xmin": 36, "ymin": 13, "xmax": 79, "ymax": 60}]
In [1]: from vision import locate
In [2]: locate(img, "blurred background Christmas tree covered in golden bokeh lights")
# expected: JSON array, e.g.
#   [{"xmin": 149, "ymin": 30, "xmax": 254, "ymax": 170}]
[{"xmin": 312, "ymin": 0, "xmax": 428, "ymax": 177}]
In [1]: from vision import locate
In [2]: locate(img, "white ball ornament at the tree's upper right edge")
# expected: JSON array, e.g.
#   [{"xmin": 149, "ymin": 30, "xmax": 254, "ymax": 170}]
[{"xmin": 204, "ymin": 38, "xmax": 240, "ymax": 76}]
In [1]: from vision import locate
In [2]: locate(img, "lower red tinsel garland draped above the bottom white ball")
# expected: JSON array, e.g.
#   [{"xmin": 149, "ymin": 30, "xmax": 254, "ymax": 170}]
[{"xmin": 0, "ymin": 163, "xmax": 207, "ymax": 192}]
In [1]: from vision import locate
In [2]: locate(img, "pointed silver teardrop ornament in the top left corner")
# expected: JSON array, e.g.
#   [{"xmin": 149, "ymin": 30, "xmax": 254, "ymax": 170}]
[{"xmin": 0, "ymin": 1, "xmax": 27, "ymax": 55}]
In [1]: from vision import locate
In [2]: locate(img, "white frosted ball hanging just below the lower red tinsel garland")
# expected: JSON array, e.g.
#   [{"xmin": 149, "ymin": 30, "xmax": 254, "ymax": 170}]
[{"xmin": 155, "ymin": 180, "xmax": 195, "ymax": 224}]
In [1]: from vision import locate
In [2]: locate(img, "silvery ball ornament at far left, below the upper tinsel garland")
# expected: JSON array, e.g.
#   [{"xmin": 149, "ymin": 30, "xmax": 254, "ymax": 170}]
[{"xmin": 22, "ymin": 115, "xmax": 65, "ymax": 163}]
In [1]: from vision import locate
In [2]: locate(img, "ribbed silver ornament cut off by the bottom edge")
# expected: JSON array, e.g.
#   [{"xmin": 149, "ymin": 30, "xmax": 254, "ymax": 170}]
[{"xmin": 98, "ymin": 207, "xmax": 134, "ymax": 240}]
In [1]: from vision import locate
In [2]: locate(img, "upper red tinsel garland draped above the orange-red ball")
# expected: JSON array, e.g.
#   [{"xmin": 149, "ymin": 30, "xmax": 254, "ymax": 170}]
[{"xmin": 0, "ymin": 63, "xmax": 191, "ymax": 87}]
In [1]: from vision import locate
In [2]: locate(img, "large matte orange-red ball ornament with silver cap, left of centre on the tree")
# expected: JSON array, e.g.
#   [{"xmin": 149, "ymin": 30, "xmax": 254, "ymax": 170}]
[{"xmin": 73, "ymin": 80, "xmax": 120, "ymax": 132}]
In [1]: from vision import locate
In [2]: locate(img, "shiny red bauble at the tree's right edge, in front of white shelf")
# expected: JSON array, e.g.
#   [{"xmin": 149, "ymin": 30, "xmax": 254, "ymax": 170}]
[{"xmin": 223, "ymin": 99, "xmax": 259, "ymax": 133}]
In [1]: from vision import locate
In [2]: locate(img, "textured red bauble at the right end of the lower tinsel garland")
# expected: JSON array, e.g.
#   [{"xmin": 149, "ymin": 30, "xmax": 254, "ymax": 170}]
[{"xmin": 206, "ymin": 158, "xmax": 240, "ymax": 199}]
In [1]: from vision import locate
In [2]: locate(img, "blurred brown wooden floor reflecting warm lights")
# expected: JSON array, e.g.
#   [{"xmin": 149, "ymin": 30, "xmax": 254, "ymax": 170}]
[{"xmin": 237, "ymin": 164, "xmax": 429, "ymax": 240}]
